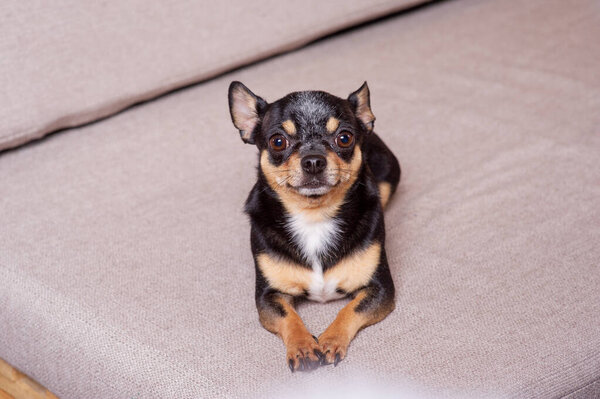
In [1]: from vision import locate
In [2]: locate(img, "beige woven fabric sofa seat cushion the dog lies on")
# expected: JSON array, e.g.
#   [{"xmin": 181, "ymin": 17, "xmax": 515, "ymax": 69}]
[{"xmin": 0, "ymin": 0, "xmax": 600, "ymax": 398}]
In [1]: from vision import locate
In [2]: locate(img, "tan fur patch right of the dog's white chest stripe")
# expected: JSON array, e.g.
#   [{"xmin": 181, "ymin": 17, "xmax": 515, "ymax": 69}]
[{"xmin": 323, "ymin": 242, "xmax": 381, "ymax": 292}]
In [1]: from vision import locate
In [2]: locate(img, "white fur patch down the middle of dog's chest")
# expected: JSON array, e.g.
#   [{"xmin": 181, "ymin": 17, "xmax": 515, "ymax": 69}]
[{"xmin": 288, "ymin": 214, "xmax": 342, "ymax": 302}]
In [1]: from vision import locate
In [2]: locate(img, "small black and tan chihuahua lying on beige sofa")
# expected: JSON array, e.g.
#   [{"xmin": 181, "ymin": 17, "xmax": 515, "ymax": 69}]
[{"xmin": 229, "ymin": 82, "xmax": 400, "ymax": 372}]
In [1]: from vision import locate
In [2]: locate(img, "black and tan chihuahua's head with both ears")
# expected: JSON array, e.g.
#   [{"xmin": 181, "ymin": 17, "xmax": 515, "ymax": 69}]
[{"xmin": 229, "ymin": 82, "xmax": 375, "ymax": 216}]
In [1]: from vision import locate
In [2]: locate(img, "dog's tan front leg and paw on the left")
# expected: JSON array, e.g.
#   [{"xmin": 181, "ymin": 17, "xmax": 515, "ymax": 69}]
[{"xmin": 257, "ymin": 291, "xmax": 323, "ymax": 372}]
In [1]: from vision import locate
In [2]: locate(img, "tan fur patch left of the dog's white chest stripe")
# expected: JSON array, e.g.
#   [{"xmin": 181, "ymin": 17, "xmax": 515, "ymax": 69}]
[{"xmin": 256, "ymin": 253, "xmax": 312, "ymax": 295}]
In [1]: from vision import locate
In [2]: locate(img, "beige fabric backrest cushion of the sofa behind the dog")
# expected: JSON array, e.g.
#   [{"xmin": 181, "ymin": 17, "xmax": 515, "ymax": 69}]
[{"xmin": 0, "ymin": 0, "xmax": 424, "ymax": 150}]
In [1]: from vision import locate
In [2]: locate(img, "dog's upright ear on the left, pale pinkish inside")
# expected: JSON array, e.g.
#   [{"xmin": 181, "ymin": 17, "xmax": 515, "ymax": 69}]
[{"xmin": 229, "ymin": 82, "xmax": 267, "ymax": 144}]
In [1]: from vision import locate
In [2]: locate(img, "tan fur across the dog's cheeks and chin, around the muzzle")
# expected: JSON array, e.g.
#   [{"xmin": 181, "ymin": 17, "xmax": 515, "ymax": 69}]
[{"xmin": 260, "ymin": 146, "xmax": 362, "ymax": 221}]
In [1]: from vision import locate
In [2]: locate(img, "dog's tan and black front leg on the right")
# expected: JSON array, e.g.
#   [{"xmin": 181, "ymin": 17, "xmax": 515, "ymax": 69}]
[{"xmin": 319, "ymin": 264, "xmax": 394, "ymax": 366}]
